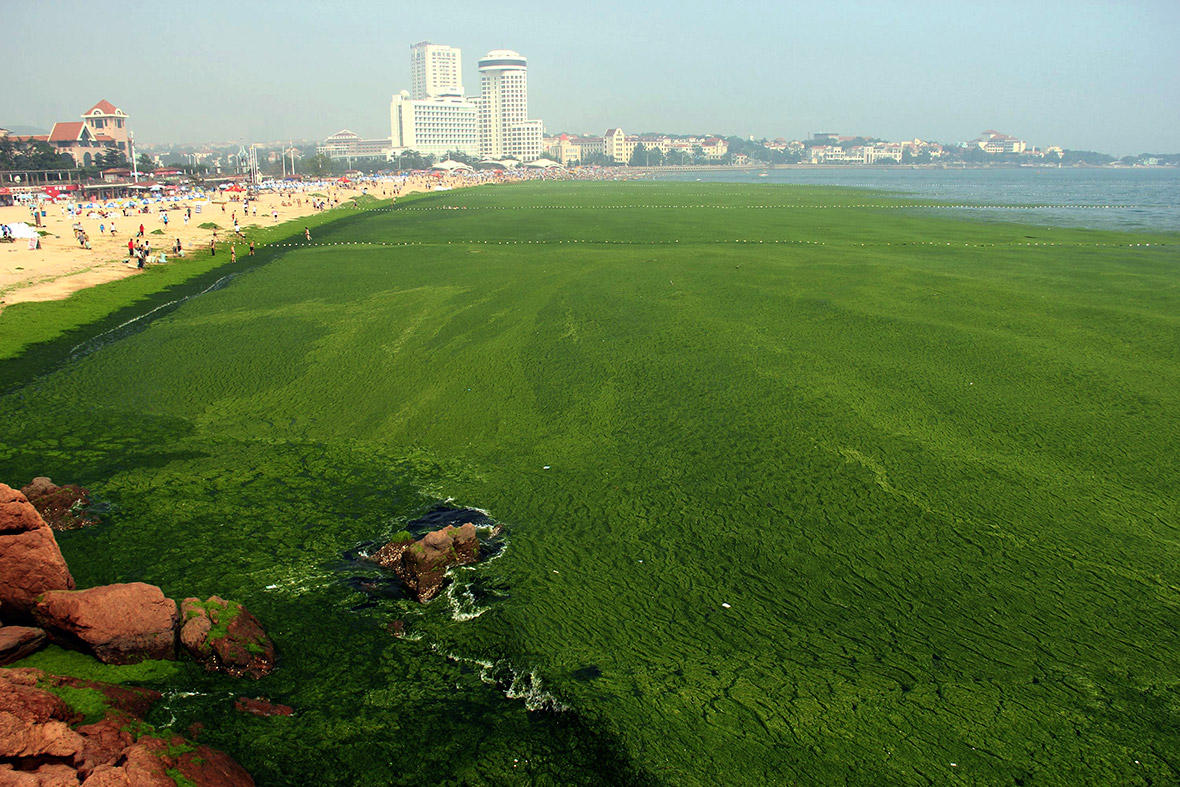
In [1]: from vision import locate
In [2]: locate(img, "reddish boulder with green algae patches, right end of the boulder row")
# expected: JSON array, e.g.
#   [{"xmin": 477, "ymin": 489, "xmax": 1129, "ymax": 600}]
[{"xmin": 181, "ymin": 596, "xmax": 275, "ymax": 678}]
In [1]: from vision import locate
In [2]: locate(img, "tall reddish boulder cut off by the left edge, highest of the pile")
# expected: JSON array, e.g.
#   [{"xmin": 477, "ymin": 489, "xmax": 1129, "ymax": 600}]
[{"xmin": 0, "ymin": 484, "xmax": 74, "ymax": 622}]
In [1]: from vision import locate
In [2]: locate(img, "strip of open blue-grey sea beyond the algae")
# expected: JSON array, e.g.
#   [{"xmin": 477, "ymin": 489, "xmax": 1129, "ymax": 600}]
[{"xmin": 654, "ymin": 166, "xmax": 1180, "ymax": 232}]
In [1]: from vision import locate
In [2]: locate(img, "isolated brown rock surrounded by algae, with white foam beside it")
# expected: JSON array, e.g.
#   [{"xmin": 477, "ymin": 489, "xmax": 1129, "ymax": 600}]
[{"xmin": 373, "ymin": 523, "xmax": 479, "ymax": 602}]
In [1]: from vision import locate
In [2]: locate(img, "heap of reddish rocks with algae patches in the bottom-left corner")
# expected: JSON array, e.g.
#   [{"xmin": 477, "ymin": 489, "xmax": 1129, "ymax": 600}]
[{"xmin": 0, "ymin": 669, "xmax": 254, "ymax": 787}]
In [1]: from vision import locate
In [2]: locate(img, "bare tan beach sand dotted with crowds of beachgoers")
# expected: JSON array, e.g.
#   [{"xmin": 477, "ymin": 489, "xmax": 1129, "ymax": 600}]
[{"xmin": 0, "ymin": 177, "xmax": 476, "ymax": 311}]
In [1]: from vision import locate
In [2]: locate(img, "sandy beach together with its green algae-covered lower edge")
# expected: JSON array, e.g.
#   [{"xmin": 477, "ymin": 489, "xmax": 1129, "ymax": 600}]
[{"xmin": 0, "ymin": 170, "xmax": 628, "ymax": 365}]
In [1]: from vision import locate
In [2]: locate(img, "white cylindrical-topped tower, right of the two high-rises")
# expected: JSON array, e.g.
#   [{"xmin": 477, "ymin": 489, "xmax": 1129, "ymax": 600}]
[{"xmin": 478, "ymin": 50, "xmax": 543, "ymax": 162}]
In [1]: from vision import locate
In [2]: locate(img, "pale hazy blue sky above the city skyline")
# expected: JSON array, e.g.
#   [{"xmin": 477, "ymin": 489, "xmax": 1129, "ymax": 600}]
[{"xmin": 0, "ymin": 0, "xmax": 1180, "ymax": 155}]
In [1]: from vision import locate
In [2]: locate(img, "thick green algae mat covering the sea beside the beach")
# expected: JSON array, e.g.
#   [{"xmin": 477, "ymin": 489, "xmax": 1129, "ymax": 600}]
[{"xmin": 0, "ymin": 183, "xmax": 1180, "ymax": 787}]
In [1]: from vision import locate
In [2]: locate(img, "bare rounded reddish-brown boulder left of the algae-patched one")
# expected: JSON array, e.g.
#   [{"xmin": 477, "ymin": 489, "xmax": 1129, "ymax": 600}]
[{"xmin": 33, "ymin": 582, "xmax": 179, "ymax": 664}]
